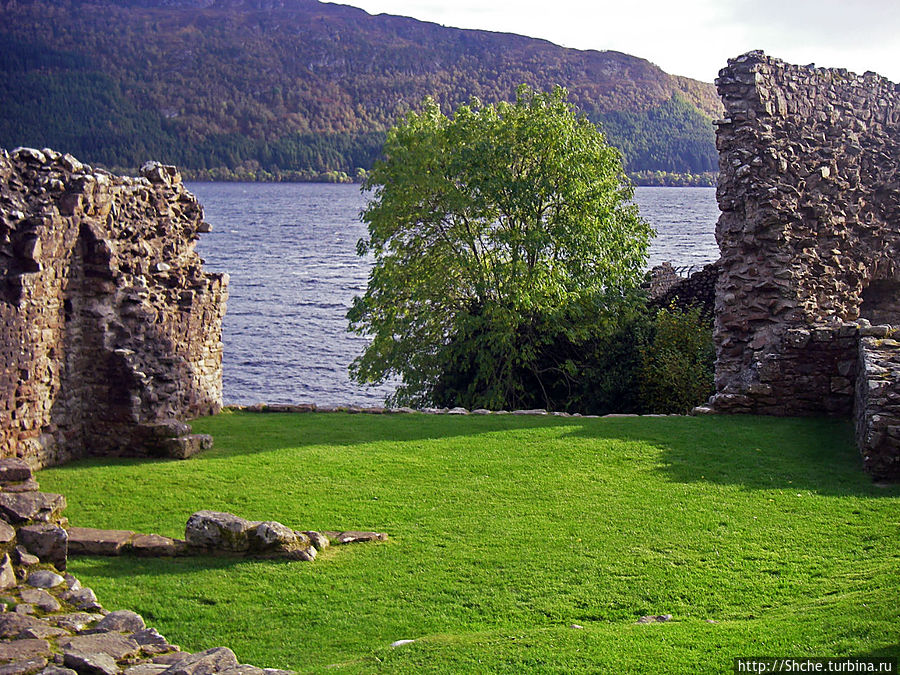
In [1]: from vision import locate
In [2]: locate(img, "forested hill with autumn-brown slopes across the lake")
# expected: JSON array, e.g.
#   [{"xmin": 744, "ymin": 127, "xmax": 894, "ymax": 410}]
[{"xmin": 0, "ymin": 0, "xmax": 720, "ymax": 177}]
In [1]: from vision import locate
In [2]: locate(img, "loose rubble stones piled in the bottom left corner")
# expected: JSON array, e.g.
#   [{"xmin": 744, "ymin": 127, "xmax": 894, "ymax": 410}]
[{"xmin": 0, "ymin": 458, "xmax": 311, "ymax": 675}]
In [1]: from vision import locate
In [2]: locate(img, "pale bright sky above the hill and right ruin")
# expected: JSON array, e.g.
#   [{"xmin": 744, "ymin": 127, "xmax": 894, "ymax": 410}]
[{"xmin": 338, "ymin": 0, "xmax": 900, "ymax": 82}]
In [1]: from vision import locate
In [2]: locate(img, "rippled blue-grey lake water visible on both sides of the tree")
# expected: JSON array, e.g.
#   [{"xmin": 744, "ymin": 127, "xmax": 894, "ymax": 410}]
[{"xmin": 188, "ymin": 183, "xmax": 719, "ymax": 405}]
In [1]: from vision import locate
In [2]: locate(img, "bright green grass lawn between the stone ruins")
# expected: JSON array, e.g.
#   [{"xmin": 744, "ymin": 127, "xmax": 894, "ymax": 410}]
[{"xmin": 38, "ymin": 414, "xmax": 900, "ymax": 673}]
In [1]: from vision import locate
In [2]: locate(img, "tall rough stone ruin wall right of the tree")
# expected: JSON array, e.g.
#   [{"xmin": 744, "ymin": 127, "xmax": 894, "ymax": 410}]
[{"xmin": 711, "ymin": 52, "xmax": 900, "ymax": 478}]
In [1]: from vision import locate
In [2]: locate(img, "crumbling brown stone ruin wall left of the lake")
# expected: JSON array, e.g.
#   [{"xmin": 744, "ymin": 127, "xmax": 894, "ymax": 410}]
[{"xmin": 0, "ymin": 149, "xmax": 227, "ymax": 467}]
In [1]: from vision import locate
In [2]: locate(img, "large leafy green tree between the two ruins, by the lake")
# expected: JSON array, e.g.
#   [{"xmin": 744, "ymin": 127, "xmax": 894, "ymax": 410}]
[{"xmin": 348, "ymin": 85, "xmax": 652, "ymax": 408}]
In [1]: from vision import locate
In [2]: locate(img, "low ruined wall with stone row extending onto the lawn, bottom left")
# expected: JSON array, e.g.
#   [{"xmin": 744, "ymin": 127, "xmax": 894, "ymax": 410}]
[{"xmin": 0, "ymin": 458, "xmax": 387, "ymax": 675}]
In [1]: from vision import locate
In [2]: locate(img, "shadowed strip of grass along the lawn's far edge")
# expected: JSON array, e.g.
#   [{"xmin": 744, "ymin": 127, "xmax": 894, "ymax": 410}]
[{"xmin": 47, "ymin": 413, "xmax": 900, "ymax": 497}]
